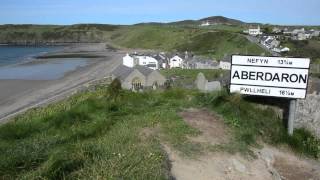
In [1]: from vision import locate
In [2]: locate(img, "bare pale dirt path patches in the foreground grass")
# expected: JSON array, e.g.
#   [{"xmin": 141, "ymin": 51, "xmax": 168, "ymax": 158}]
[{"xmin": 164, "ymin": 109, "xmax": 320, "ymax": 180}]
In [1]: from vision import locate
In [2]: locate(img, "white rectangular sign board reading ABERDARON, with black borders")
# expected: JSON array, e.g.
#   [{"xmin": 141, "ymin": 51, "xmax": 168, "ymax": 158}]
[{"xmin": 230, "ymin": 55, "xmax": 310, "ymax": 99}]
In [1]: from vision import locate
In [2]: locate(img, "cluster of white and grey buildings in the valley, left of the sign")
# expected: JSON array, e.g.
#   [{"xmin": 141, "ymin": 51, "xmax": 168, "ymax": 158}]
[{"xmin": 111, "ymin": 51, "xmax": 231, "ymax": 91}]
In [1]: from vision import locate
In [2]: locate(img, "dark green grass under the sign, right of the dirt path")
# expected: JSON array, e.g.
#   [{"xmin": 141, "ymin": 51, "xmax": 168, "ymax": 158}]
[{"xmin": 198, "ymin": 91, "xmax": 320, "ymax": 158}]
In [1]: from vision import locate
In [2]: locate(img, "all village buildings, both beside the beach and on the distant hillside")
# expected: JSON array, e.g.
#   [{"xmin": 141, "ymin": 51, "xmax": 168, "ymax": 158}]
[{"xmin": 111, "ymin": 21, "xmax": 320, "ymax": 91}]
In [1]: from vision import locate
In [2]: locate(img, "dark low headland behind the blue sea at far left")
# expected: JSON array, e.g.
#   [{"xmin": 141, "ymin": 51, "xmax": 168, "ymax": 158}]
[{"xmin": 0, "ymin": 24, "xmax": 118, "ymax": 44}]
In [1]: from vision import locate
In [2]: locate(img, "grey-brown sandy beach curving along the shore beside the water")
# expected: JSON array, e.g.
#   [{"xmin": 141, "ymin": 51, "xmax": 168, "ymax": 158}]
[{"xmin": 0, "ymin": 44, "xmax": 125, "ymax": 123}]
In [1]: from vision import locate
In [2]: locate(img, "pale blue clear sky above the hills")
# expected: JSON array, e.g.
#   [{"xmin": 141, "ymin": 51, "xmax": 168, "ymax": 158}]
[{"xmin": 0, "ymin": 0, "xmax": 320, "ymax": 25}]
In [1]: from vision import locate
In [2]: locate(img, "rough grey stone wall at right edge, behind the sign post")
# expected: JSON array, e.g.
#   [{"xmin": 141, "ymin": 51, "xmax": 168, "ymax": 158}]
[{"xmin": 294, "ymin": 93, "xmax": 320, "ymax": 138}]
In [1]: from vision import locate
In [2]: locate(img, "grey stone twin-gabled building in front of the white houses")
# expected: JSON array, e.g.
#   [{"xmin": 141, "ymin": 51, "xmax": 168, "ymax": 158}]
[{"xmin": 111, "ymin": 65, "xmax": 166, "ymax": 91}]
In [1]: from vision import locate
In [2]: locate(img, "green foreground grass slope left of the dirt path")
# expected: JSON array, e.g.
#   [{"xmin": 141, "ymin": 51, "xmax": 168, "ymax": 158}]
[{"xmin": 0, "ymin": 90, "xmax": 197, "ymax": 179}]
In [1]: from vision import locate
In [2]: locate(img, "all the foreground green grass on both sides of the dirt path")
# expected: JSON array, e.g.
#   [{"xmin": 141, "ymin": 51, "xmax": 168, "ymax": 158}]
[{"xmin": 0, "ymin": 83, "xmax": 320, "ymax": 179}]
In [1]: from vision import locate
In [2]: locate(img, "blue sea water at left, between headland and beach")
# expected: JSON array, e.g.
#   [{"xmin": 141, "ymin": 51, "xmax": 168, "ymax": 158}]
[{"xmin": 0, "ymin": 45, "xmax": 88, "ymax": 80}]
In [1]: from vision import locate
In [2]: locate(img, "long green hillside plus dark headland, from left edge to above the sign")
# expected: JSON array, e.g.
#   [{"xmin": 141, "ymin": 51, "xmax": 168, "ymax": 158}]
[{"xmin": 0, "ymin": 24, "xmax": 263, "ymax": 58}]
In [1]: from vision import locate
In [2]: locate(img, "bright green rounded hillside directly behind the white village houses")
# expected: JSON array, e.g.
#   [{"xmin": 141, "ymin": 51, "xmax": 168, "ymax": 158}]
[{"xmin": 111, "ymin": 25, "xmax": 265, "ymax": 59}]
